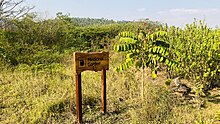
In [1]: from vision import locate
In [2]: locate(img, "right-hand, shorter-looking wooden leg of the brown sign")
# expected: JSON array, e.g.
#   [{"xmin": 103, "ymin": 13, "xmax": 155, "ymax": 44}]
[{"xmin": 101, "ymin": 70, "xmax": 106, "ymax": 113}]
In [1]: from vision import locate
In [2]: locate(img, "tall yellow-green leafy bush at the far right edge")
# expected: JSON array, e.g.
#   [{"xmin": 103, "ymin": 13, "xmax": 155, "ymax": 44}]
[{"xmin": 162, "ymin": 21, "xmax": 220, "ymax": 93}]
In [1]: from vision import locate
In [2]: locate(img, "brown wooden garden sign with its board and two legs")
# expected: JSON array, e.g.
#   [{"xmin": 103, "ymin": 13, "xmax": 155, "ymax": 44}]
[{"xmin": 74, "ymin": 52, "xmax": 109, "ymax": 123}]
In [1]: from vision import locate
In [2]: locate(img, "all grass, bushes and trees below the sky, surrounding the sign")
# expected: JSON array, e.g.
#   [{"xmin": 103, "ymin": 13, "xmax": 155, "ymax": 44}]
[{"xmin": 0, "ymin": 5, "xmax": 220, "ymax": 124}]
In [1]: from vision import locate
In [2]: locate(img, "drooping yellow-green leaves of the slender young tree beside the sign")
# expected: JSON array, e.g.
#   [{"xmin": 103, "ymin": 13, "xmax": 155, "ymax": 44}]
[{"xmin": 114, "ymin": 26, "xmax": 178, "ymax": 78}]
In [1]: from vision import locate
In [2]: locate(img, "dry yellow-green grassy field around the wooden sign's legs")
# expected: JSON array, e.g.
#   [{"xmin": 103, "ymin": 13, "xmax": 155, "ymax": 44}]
[{"xmin": 0, "ymin": 53, "xmax": 220, "ymax": 124}]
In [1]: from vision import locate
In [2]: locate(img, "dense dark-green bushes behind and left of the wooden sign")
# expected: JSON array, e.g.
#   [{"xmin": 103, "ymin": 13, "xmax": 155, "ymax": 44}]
[{"xmin": 0, "ymin": 13, "xmax": 150, "ymax": 66}]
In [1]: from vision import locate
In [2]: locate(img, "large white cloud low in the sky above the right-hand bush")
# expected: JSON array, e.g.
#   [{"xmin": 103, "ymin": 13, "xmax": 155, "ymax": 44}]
[{"xmin": 152, "ymin": 8, "xmax": 220, "ymax": 28}]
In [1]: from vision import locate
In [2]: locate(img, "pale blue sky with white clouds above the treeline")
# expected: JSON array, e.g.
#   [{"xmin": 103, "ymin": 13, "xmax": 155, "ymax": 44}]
[{"xmin": 25, "ymin": 0, "xmax": 220, "ymax": 28}]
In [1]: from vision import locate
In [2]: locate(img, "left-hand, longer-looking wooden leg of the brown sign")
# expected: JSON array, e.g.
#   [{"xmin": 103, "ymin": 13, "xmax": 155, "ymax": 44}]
[{"xmin": 76, "ymin": 73, "xmax": 82, "ymax": 124}]
